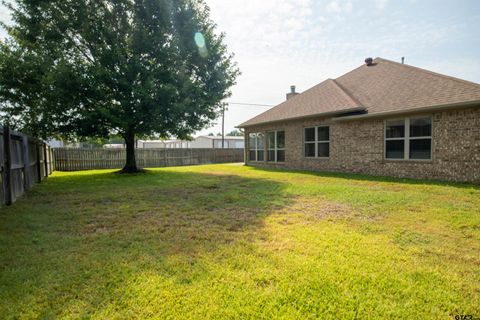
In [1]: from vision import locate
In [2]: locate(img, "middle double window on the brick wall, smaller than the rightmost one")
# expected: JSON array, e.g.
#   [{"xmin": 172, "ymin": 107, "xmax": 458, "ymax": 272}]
[{"xmin": 304, "ymin": 126, "xmax": 330, "ymax": 158}]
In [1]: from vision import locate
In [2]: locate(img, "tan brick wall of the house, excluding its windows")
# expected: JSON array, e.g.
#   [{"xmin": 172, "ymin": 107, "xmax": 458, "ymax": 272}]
[{"xmin": 245, "ymin": 108, "xmax": 480, "ymax": 183}]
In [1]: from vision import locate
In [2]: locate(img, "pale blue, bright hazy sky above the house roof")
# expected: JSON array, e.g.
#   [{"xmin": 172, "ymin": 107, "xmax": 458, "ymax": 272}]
[{"xmin": 0, "ymin": 0, "xmax": 480, "ymax": 134}]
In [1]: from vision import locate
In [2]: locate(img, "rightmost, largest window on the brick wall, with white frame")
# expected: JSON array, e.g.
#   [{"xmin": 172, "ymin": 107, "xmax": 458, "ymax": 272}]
[{"xmin": 385, "ymin": 117, "xmax": 432, "ymax": 160}]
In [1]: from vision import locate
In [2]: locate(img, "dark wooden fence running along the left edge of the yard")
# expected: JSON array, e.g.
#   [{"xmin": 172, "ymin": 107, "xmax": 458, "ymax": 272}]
[{"xmin": 0, "ymin": 127, "xmax": 54, "ymax": 205}]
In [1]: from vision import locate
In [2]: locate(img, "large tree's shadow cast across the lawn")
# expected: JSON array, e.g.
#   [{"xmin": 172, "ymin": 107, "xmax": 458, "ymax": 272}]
[{"xmin": 0, "ymin": 171, "xmax": 292, "ymax": 318}]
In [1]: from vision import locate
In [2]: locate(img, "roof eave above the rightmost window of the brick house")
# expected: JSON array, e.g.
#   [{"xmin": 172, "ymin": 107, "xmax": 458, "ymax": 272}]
[{"xmin": 333, "ymin": 100, "xmax": 480, "ymax": 121}]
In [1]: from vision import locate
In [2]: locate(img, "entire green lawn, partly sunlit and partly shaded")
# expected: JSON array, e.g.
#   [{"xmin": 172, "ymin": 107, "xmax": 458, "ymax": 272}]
[{"xmin": 0, "ymin": 164, "xmax": 480, "ymax": 319}]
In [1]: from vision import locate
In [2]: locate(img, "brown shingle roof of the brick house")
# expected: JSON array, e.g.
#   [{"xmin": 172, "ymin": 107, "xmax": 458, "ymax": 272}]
[{"xmin": 239, "ymin": 58, "xmax": 480, "ymax": 127}]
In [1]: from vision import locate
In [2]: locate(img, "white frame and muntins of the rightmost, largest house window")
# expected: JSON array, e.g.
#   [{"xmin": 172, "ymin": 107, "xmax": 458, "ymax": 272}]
[{"xmin": 383, "ymin": 115, "xmax": 433, "ymax": 162}]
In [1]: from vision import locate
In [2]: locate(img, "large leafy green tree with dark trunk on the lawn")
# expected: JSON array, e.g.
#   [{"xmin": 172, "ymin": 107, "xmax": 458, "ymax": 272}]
[{"xmin": 0, "ymin": 0, "xmax": 239, "ymax": 171}]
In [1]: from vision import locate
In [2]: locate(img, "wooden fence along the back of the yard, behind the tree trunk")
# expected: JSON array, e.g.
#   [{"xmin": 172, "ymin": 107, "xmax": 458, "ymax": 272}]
[{"xmin": 53, "ymin": 148, "xmax": 243, "ymax": 171}]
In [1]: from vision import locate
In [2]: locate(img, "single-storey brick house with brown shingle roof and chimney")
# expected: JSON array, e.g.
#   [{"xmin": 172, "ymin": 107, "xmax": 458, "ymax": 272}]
[{"xmin": 238, "ymin": 58, "xmax": 480, "ymax": 183}]
